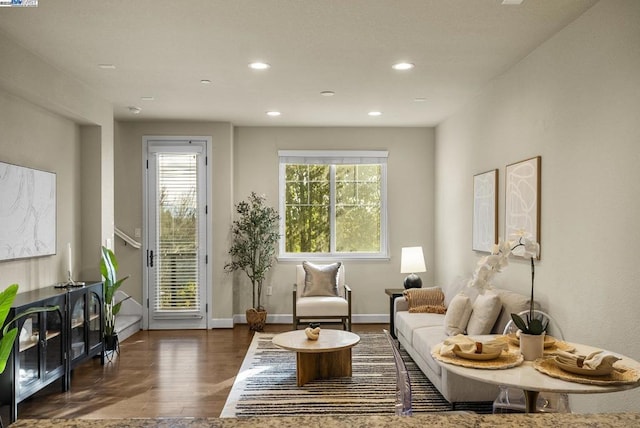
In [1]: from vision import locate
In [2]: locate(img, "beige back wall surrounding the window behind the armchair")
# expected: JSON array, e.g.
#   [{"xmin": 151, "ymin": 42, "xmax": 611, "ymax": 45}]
[{"xmin": 234, "ymin": 127, "xmax": 434, "ymax": 322}]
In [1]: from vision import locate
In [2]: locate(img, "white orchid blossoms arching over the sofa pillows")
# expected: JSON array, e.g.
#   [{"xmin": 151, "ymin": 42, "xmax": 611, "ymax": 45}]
[{"xmin": 468, "ymin": 231, "xmax": 540, "ymax": 294}]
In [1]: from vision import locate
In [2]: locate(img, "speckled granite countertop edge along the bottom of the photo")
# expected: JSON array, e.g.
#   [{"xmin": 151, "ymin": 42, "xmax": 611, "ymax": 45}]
[{"xmin": 10, "ymin": 413, "xmax": 640, "ymax": 428}]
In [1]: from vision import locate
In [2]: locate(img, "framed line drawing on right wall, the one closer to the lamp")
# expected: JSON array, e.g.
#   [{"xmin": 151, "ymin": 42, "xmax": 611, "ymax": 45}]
[{"xmin": 472, "ymin": 169, "xmax": 498, "ymax": 253}]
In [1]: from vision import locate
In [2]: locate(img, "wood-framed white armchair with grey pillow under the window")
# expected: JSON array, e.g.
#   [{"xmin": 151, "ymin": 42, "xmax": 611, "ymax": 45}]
[{"xmin": 293, "ymin": 262, "xmax": 351, "ymax": 331}]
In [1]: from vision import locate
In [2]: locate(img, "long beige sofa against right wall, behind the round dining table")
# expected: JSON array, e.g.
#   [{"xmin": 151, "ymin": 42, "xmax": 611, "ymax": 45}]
[{"xmin": 394, "ymin": 289, "xmax": 529, "ymax": 407}]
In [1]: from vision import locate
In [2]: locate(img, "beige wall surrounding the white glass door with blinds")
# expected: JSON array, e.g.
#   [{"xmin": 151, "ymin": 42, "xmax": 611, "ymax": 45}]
[{"xmin": 114, "ymin": 122, "xmax": 233, "ymax": 327}]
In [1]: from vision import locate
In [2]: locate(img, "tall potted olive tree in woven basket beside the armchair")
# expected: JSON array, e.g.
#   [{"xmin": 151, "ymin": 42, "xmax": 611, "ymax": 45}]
[{"xmin": 224, "ymin": 192, "xmax": 280, "ymax": 331}]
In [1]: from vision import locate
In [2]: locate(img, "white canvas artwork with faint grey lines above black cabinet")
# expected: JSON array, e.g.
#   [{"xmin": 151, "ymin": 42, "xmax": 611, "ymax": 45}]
[{"xmin": 0, "ymin": 162, "xmax": 56, "ymax": 260}]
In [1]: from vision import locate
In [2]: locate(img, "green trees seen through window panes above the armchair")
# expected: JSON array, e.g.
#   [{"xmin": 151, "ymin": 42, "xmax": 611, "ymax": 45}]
[{"xmin": 282, "ymin": 163, "xmax": 384, "ymax": 254}]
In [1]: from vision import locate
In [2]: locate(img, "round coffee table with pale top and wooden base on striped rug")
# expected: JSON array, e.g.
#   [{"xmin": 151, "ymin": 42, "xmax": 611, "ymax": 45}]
[{"xmin": 272, "ymin": 329, "xmax": 360, "ymax": 386}]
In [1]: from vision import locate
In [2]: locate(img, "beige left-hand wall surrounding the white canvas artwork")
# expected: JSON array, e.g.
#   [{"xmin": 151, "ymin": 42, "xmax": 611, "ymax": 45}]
[{"xmin": 0, "ymin": 35, "xmax": 113, "ymax": 291}]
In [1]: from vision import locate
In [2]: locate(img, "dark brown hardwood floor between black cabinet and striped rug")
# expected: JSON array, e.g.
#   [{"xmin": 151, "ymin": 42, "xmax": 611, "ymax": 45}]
[{"xmin": 10, "ymin": 324, "xmax": 388, "ymax": 420}]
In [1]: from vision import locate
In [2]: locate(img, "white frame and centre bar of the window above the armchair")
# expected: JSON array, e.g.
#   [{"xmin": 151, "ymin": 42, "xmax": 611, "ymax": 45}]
[{"xmin": 278, "ymin": 150, "xmax": 389, "ymax": 261}]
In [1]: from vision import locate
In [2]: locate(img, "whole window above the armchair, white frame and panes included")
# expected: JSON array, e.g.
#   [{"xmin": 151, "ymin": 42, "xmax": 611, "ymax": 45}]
[{"xmin": 278, "ymin": 151, "xmax": 388, "ymax": 258}]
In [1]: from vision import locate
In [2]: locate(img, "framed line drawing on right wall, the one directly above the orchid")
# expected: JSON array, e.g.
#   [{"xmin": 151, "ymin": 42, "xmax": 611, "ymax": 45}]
[{"xmin": 504, "ymin": 156, "xmax": 541, "ymax": 257}]
